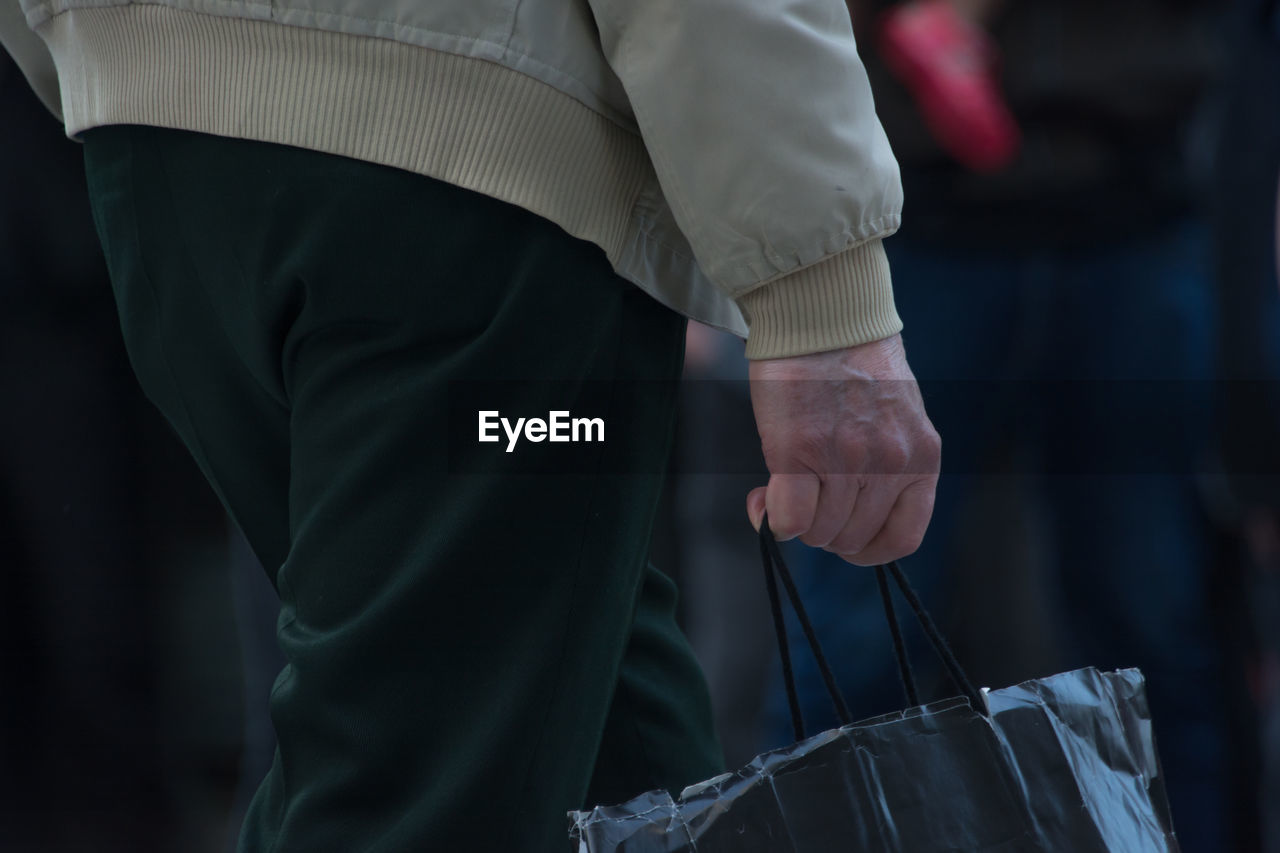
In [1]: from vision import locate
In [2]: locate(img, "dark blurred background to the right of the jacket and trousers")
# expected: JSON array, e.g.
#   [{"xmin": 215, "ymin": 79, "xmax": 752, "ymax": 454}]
[{"xmin": 654, "ymin": 0, "xmax": 1280, "ymax": 853}]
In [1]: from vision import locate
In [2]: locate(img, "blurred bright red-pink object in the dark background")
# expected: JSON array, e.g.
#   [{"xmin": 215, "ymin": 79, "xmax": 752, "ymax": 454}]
[{"xmin": 879, "ymin": 0, "xmax": 1021, "ymax": 172}]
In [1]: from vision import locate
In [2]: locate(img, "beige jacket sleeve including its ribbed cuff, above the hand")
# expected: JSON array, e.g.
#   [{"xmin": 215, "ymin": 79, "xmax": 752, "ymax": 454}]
[{"xmin": 589, "ymin": 0, "xmax": 902, "ymax": 359}]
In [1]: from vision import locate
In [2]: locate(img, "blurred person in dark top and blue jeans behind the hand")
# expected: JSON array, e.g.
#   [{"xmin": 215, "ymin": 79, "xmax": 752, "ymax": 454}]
[{"xmin": 768, "ymin": 0, "xmax": 1239, "ymax": 853}]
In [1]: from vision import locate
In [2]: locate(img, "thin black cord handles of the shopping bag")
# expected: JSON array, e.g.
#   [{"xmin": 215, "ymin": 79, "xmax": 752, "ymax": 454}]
[{"xmin": 760, "ymin": 515, "xmax": 987, "ymax": 740}]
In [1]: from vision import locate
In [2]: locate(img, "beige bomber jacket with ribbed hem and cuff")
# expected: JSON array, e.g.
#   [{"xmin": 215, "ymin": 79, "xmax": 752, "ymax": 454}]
[{"xmin": 0, "ymin": 0, "xmax": 901, "ymax": 357}]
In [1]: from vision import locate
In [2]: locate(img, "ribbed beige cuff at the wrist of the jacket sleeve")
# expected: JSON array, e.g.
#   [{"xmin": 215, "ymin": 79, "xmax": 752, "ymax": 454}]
[{"xmin": 737, "ymin": 240, "xmax": 902, "ymax": 359}]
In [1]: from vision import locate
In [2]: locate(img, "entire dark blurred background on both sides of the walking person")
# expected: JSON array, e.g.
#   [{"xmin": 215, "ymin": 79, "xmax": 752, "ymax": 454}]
[{"xmin": 0, "ymin": 0, "xmax": 1280, "ymax": 853}]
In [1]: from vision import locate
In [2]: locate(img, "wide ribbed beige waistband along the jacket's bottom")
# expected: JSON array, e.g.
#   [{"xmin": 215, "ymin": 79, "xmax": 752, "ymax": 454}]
[{"xmin": 44, "ymin": 5, "xmax": 652, "ymax": 257}]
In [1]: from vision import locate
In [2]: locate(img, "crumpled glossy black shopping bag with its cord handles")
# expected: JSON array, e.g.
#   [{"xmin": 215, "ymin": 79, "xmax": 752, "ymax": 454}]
[{"xmin": 570, "ymin": 524, "xmax": 1179, "ymax": 853}]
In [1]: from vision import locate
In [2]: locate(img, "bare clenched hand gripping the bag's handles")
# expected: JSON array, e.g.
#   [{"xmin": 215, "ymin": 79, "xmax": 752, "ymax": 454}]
[{"xmin": 746, "ymin": 336, "xmax": 942, "ymax": 566}]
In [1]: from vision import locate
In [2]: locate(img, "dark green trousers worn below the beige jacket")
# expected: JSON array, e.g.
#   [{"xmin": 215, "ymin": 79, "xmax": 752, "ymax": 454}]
[{"xmin": 84, "ymin": 127, "xmax": 721, "ymax": 853}]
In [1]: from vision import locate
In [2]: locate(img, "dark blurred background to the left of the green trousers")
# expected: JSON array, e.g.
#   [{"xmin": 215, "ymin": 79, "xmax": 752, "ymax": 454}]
[{"xmin": 0, "ymin": 51, "xmax": 280, "ymax": 853}]
